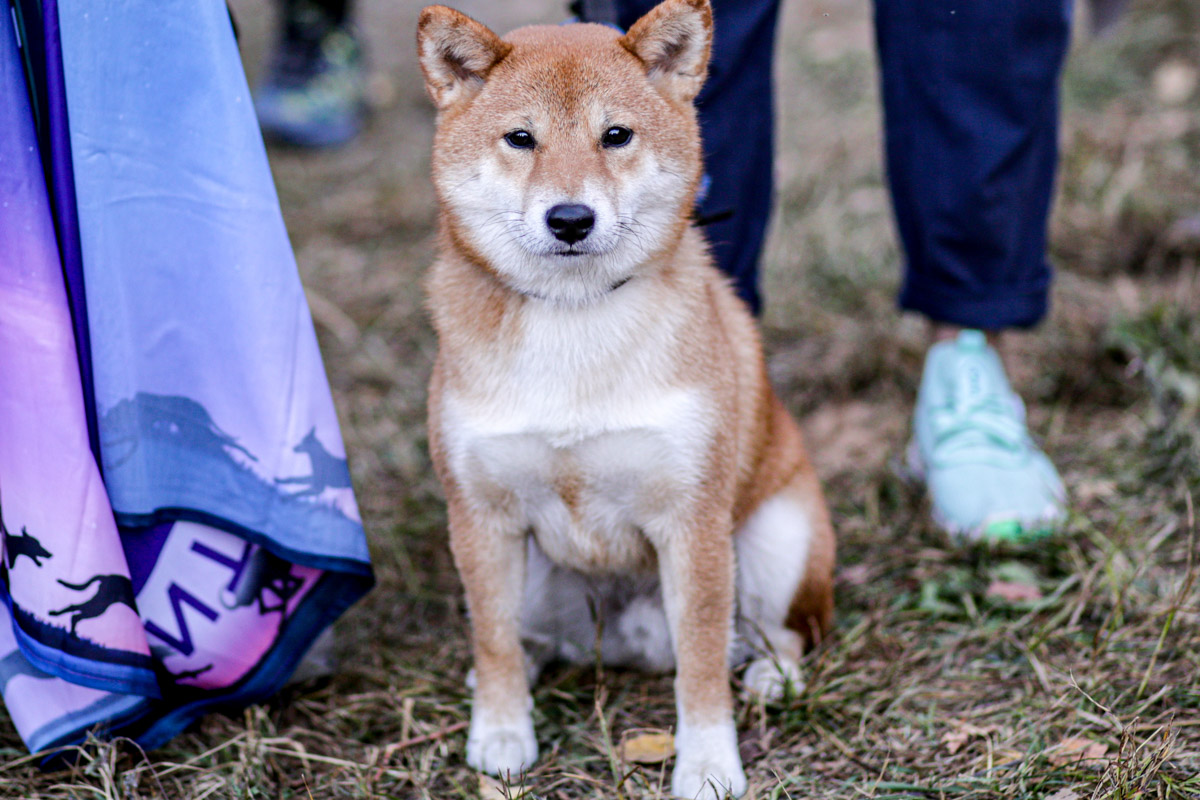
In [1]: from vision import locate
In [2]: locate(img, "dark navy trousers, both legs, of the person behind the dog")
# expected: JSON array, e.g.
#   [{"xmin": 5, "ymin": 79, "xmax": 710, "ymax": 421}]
[{"xmin": 595, "ymin": 0, "xmax": 1070, "ymax": 330}]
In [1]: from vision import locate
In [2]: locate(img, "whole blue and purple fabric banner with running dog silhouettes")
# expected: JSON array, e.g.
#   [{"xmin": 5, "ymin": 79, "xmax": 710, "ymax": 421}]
[{"xmin": 0, "ymin": 0, "xmax": 372, "ymax": 750}]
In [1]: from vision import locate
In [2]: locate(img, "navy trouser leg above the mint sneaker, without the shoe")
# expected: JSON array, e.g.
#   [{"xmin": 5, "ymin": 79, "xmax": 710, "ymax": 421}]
[{"xmin": 875, "ymin": 0, "xmax": 1069, "ymax": 330}]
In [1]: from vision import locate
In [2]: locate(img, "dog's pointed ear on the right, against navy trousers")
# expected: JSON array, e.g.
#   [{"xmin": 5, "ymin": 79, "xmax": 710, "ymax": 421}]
[{"xmin": 620, "ymin": 0, "xmax": 713, "ymax": 103}]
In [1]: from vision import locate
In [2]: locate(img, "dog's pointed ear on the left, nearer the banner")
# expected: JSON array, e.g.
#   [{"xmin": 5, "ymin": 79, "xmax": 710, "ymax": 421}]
[{"xmin": 416, "ymin": 6, "xmax": 512, "ymax": 109}]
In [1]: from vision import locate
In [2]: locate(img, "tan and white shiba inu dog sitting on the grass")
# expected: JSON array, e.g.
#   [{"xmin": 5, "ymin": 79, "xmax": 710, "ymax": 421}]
[{"xmin": 418, "ymin": 0, "xmax": 834, "ymax": 798}]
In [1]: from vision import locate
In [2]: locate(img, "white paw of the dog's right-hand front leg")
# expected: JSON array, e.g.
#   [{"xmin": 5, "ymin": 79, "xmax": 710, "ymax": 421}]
[{"xmin": 671, "ymin": 722, "xmax": 746, "ymax": 800}]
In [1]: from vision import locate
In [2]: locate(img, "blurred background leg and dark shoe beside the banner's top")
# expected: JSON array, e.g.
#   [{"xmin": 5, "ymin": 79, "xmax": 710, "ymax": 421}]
[{"xmin": 254, "ymin": 0, "xmax": 365, "ymax": 148}]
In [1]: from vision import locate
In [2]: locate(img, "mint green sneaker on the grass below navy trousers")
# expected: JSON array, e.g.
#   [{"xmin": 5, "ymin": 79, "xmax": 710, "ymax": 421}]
[{"xmin": 908, "ymin": 331, "xmax": 1067, "ymax": 540}]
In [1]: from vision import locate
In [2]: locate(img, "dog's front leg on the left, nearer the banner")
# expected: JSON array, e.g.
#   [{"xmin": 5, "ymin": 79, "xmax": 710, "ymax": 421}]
[{"xmin": 450, "ymin": 500, "xmax": 538, "ymax": 777}]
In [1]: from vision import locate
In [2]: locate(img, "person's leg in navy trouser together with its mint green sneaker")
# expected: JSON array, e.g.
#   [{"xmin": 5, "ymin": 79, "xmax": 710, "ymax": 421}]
[{"xmin": 875, "ymin": 0, "xmax": 1070, "ymax": 537}]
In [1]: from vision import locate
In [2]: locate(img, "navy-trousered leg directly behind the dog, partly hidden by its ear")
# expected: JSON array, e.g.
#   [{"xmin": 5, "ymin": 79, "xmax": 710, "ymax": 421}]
[{"xmin": 588, "ymin": 0, "xmax": 779, "ymax": 313}]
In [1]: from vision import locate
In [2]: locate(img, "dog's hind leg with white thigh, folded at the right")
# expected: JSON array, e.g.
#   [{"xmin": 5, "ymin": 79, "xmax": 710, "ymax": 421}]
[{"xmin": 734, "ymin": 469, "xmax": 834, "ymax": 699}]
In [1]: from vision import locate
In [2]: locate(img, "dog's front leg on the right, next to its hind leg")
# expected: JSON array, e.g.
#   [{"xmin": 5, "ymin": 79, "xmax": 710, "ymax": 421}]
[{"xmin": 659, "ymin": 515, "xmax": 746, "ymax": 800}]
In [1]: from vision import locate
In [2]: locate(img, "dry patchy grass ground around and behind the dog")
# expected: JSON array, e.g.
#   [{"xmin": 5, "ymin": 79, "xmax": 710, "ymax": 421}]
[{"xmin": 0, "ymin": 0, "xmax": 1200, "ymax": 800}]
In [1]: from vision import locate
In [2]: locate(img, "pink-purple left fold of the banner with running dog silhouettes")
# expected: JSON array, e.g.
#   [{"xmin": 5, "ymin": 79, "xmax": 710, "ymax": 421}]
[{"xmin": 0, "ymin": 0, "xmax": 158, "ymax": 700}]
